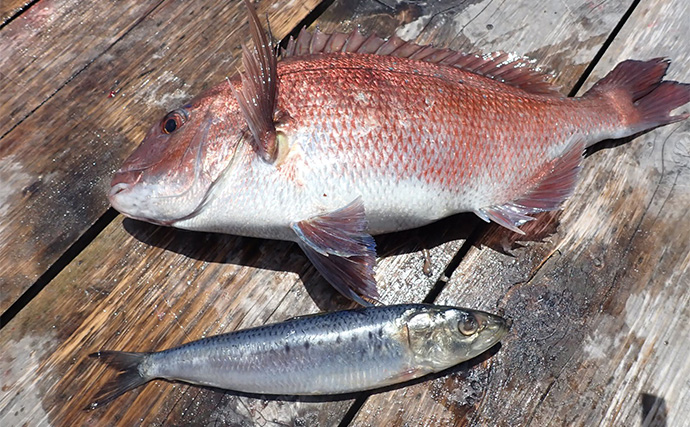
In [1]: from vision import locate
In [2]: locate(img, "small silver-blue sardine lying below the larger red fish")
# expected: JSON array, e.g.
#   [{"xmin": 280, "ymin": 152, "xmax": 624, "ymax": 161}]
[{"xmin": 91, "ymin": 304, "xmax": 509, "ymax": 408}]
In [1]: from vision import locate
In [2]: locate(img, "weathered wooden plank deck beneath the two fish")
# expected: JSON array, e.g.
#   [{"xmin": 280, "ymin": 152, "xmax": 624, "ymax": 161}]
[{"xmin": 0, "ymin": 0, "xmax": 690, "ymax": 426}]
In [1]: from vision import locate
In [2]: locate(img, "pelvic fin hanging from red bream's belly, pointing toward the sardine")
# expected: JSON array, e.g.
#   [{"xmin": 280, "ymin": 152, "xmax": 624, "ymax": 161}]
[{"xmin": 292, "ymin": 198, "xmax": 379, "ymax": 306}]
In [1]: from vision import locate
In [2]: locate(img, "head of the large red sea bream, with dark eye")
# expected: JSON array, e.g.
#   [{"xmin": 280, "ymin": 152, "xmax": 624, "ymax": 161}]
[{"xmin": 108, "ymin": 88, "xmax": 246, "ymax": 225}]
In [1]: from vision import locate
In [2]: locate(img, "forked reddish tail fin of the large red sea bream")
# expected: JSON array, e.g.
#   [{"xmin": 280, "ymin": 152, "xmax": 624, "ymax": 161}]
[{"xmin": 584, "ymin": 58, "xmax": 690, "ymax": 144}]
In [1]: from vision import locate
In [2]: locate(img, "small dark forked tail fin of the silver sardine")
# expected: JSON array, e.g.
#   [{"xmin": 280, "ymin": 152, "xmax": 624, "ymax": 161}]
[{"xmin": 84, "ymin": 351, "xmax": 151, "ymax": 410}]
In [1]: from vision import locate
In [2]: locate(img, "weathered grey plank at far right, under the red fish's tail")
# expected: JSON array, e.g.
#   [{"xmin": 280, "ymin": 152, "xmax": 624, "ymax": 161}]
[{"xmin": 354, "ymin": 1, "xmax": 690, "ymax": 426}]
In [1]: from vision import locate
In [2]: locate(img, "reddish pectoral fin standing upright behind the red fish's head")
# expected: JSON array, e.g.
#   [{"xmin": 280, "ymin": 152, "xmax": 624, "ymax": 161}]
[{"xmin": 233, "ymin": 0, "xmax": 278, "ymax": 162}]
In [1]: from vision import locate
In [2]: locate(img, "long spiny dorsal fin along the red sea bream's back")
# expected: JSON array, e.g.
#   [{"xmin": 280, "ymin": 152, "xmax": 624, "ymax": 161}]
[{"xmin": 281, "ymin": 28, "xmax": 562, "ymax": 96}]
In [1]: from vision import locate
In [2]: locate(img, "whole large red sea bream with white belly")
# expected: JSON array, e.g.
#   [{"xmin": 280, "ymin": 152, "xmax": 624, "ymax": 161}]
[{"xmin": 110, "ymin": 0, "xmax": 690, "ymax": 304}]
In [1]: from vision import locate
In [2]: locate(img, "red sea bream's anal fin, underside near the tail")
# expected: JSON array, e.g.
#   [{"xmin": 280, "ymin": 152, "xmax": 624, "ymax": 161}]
[{"xmin": 475, "ymin": 139, "xmax": 585, "ymax": 234}]
